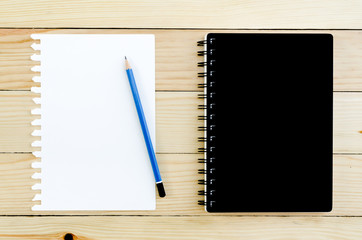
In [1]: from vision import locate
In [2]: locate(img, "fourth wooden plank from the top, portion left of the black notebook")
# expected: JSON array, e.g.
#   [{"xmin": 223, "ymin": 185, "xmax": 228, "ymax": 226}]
[{"xmin": 0, "ymin": 154, "xmax": 203, "ymax": 215}]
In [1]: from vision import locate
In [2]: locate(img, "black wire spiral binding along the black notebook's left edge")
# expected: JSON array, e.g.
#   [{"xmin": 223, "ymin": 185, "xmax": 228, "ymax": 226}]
[{"xmin": 197, "ymin": 35, "xmax": 216, "ymax": 207}]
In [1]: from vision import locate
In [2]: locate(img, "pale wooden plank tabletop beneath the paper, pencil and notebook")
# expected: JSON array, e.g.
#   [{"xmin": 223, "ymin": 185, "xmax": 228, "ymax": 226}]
[{"xmin": 0, "ymin": 0, "xmax": 362, "ymax": 240}]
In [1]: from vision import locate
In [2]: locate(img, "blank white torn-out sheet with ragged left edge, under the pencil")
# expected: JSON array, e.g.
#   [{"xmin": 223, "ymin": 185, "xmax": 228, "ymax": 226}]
[{"xmin": 32, "ymin": 34, "xmax": 156, "ymax": 210}]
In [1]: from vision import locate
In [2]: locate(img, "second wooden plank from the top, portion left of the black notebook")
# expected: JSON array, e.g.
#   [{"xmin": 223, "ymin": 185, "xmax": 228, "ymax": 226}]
[{"xmin": 0, "ymin": 29, "xmax": 199, "ymax": 90}]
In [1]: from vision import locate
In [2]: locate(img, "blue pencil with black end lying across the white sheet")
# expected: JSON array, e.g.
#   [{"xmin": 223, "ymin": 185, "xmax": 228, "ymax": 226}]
[{"xmin": 125, "ymin": 57, "xmax": 166, "ymax": 197}]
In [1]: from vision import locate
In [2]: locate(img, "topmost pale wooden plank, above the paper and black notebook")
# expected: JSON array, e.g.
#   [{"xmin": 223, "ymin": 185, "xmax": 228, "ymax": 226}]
[{"xmin": 0, "ymin": 0, "xmax": 362, "ymax": 29}]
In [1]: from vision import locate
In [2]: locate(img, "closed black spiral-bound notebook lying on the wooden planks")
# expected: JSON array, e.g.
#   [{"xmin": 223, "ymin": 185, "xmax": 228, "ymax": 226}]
[{"xmin": 198, "ymin": 33, "xmax": 333, "ymax": 212}]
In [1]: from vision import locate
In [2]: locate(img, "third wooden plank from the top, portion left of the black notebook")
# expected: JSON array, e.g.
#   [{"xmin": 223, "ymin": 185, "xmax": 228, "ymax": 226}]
[{"xmin": 0, "ymin": 91, "xmax": 202, "ymax": 153}]
